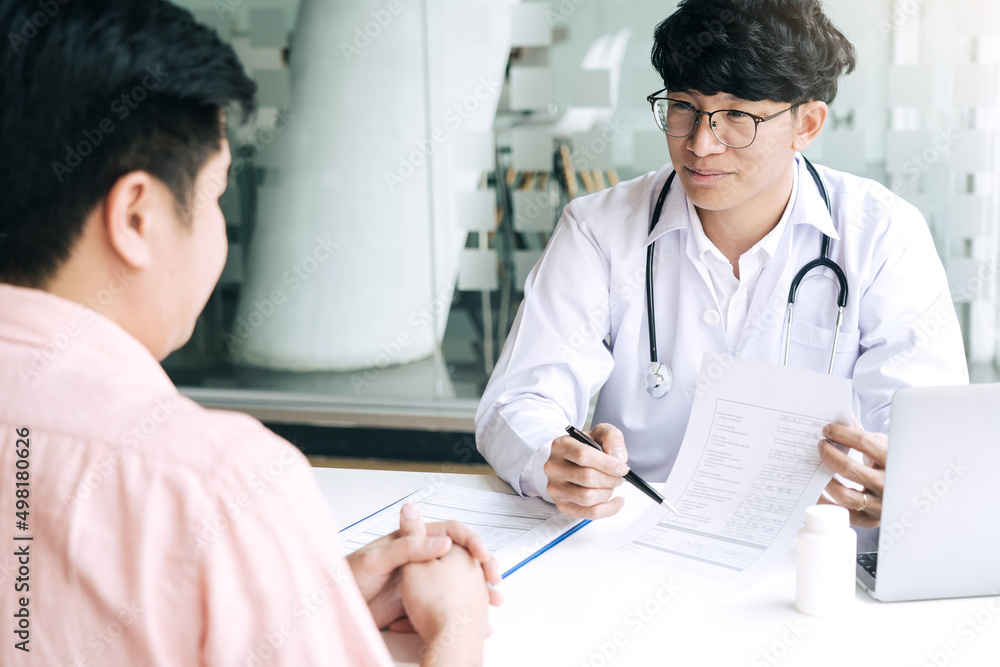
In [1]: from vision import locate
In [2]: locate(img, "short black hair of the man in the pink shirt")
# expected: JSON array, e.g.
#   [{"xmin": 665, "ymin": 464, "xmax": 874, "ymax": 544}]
[{"xmin": 0, "ymin": 0, "xmax": 256, "ymax": 287}]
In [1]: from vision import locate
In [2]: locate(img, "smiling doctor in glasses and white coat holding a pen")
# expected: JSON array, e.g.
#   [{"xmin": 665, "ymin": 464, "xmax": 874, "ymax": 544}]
[{"xmin": 476, "ymin": 0, "xmax": 968, "ymax": 526}]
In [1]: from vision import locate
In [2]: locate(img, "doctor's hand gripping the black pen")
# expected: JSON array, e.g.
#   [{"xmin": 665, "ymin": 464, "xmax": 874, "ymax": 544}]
[{"xmin": 545, "ymin": 424, "xmax": 628, "ymax": 519}]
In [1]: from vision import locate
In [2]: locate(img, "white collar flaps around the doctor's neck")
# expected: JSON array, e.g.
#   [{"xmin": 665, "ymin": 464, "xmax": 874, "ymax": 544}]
[{"xmin": 646, "ymin": 153, "xmax": 840, "ymax": 248}]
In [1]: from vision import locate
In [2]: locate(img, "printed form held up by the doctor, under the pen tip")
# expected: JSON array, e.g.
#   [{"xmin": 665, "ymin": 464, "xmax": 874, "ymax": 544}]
[{"xmin": 597, "ymin": 353, "xmax": 853, "ymax": 593}]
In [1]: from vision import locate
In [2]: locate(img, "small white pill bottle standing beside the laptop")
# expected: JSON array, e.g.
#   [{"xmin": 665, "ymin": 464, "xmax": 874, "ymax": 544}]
[{"xmin": 795, "ymin": 505, "xmax": 858, "ymax": 616}]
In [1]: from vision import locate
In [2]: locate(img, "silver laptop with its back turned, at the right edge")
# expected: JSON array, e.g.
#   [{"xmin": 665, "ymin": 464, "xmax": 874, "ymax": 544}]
[{"xmin": 857, "ymin": 384, "xmax": 1000, "ymax": 602}]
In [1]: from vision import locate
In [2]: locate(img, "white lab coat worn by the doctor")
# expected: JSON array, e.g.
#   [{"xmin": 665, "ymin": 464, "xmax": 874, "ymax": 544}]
[{"xmin": 476, "ymin": 156, "xmax": 968, "ymax": 500}]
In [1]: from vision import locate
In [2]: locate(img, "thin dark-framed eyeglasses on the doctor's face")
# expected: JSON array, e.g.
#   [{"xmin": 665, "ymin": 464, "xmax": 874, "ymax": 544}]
[{"xmin": 646, "ymin": 88, "xmax": 802, "ymax": 148}]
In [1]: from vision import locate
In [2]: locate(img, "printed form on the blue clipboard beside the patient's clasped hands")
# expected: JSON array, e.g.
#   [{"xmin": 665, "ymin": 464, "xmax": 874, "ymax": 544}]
[{"xmin": 340, "ymin": 484, "xmax": 580, "ymax": 573}]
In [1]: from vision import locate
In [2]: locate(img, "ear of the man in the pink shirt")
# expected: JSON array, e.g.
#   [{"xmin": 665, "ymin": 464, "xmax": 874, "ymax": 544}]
[{"xmin": 102, "ymin": 171, "xmax": 158, "ymax": 269}]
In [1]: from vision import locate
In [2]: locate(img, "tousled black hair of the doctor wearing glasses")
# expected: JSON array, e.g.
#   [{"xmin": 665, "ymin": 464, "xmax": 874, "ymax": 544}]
[{"xmin": 652, "ymin": 0, "xmax": 856, "ymax": 104}]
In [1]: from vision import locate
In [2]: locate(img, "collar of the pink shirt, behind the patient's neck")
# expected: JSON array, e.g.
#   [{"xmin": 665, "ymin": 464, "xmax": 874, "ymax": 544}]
[{"xmin": 0, "ymin": 283, "xmax": 176, "ymax": 391}]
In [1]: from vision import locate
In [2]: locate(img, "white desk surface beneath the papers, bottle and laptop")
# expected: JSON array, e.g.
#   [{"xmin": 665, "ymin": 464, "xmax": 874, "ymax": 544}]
[{"xmin": 316, "ymin": 468, "xmax": 1000, "ymax": 667}]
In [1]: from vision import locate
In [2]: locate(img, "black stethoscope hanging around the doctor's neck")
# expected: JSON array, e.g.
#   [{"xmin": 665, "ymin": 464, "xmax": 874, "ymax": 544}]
[{"xmin": 643, "ymin": 156, "xmax": 847, "ymax": 398}]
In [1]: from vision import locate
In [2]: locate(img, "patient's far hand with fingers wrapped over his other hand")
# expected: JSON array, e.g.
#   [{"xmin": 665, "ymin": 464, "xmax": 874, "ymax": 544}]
[{"xmin": 347, "ymin": 503, "xmax": 503, "ymax": 631}]
